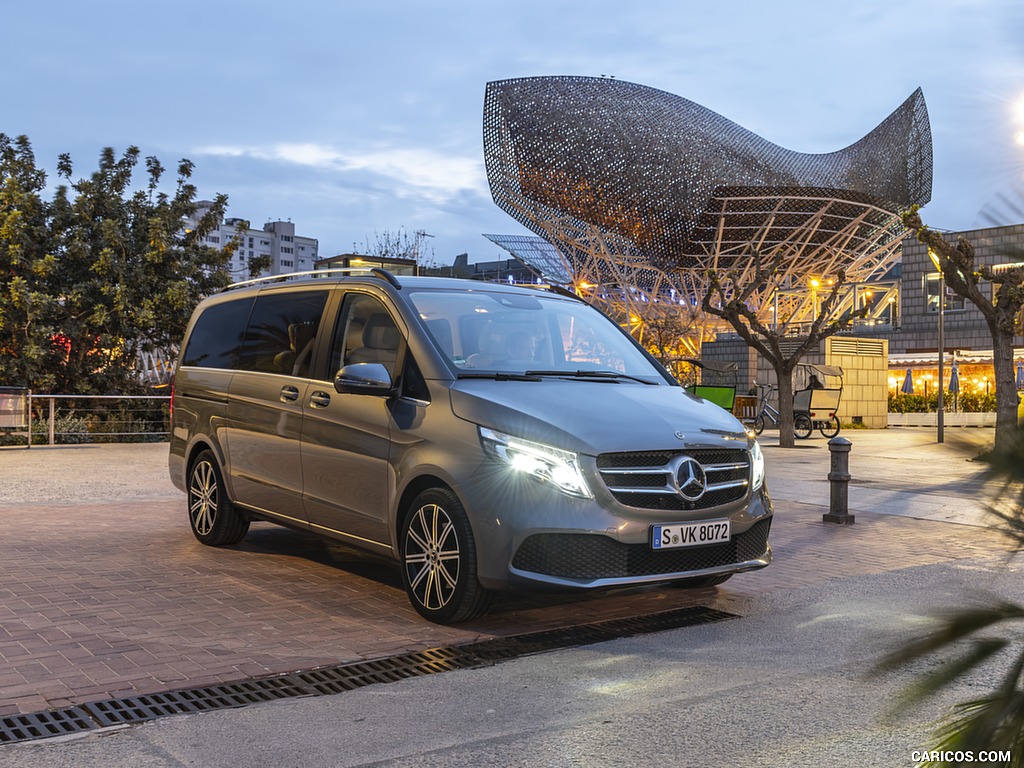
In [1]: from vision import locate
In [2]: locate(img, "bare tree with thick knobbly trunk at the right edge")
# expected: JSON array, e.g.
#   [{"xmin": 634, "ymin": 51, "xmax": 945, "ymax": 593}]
[{"xmin": 903, "ymin": 206, "xmax": 1024, "ymax": 452}]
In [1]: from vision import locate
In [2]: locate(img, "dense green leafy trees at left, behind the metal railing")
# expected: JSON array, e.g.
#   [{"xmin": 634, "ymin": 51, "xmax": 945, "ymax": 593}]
[{"xmin": 0, "ymin": 134, "xmax": 237, "ymax": 394}]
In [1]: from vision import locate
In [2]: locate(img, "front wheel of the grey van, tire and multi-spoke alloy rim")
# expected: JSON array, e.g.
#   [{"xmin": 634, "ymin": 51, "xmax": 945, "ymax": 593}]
[{"xmin": 399, "ymin": 487, "xmax": 492, "ymax": 624}]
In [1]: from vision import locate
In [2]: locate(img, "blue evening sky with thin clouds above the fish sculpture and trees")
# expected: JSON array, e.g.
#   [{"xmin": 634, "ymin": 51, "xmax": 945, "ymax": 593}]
[{"xmin": 0, "ymin": 0, "xmax": 1024, "ymax": 263}]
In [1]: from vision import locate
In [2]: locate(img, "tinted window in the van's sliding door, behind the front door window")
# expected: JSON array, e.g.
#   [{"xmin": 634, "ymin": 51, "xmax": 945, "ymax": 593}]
[{"xmin": 239, "ymin": 291, "xmax": 327, "ymax": 377}]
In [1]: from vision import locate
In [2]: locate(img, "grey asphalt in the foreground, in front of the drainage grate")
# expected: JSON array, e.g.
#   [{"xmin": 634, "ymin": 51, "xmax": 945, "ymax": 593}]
[{"xmin": 6, "ymin": 559, "xmax": 1024, "ymax": 768}]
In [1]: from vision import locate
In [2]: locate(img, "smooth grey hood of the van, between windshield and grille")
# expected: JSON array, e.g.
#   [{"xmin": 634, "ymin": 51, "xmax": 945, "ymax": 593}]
[{"xmin": 451, "ymin": 378, "xmax": 746, "ymax": 456}]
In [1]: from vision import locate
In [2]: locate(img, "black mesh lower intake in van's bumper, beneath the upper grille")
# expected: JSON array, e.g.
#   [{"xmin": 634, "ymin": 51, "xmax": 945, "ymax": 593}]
[{"xmin": 512, "ymin": 517, "xmax": 771, "ymax": 579}]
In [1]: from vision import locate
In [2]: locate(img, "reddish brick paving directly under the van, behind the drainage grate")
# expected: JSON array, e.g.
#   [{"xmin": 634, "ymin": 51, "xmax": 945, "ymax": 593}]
[{"xmin": 0, "ymin": 496, "xmax": 1004, "ymax": 716}]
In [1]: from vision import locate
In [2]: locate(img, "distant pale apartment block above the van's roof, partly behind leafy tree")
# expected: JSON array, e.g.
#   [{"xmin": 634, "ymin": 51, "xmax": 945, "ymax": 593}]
[{"xmin": 196, "ymin": 201, "xmax": 318, "ymax": 281}]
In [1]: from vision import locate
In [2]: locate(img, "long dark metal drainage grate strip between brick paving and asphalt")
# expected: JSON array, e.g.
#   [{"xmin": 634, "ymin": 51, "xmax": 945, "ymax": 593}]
[{"xmin": 0, "ymin": 606, "xmax": 737, "ymax": 744}]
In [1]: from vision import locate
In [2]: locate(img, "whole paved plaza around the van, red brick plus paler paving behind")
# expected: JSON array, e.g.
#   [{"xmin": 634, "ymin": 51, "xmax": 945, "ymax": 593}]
[{"xmin": 0, "ymin": 429, "xmax": 1005, "ymax": 716}]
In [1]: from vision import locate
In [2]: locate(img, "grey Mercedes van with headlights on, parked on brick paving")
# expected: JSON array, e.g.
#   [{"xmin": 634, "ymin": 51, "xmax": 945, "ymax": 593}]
[{"xmin": 170, "ymin": 269, "xmax": 772, "ymax": 624}]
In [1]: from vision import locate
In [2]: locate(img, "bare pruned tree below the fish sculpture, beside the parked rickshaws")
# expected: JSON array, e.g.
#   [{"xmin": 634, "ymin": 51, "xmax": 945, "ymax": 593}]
[{"xmin": 701, "ymin": 251, "xmax": 849, "ymax": 447}]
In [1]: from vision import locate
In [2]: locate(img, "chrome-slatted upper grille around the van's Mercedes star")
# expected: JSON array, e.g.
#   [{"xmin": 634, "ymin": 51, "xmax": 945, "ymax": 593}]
[{"xmin": 597, "ymin": 449, "xmax": 750, "ymax": 511}]
